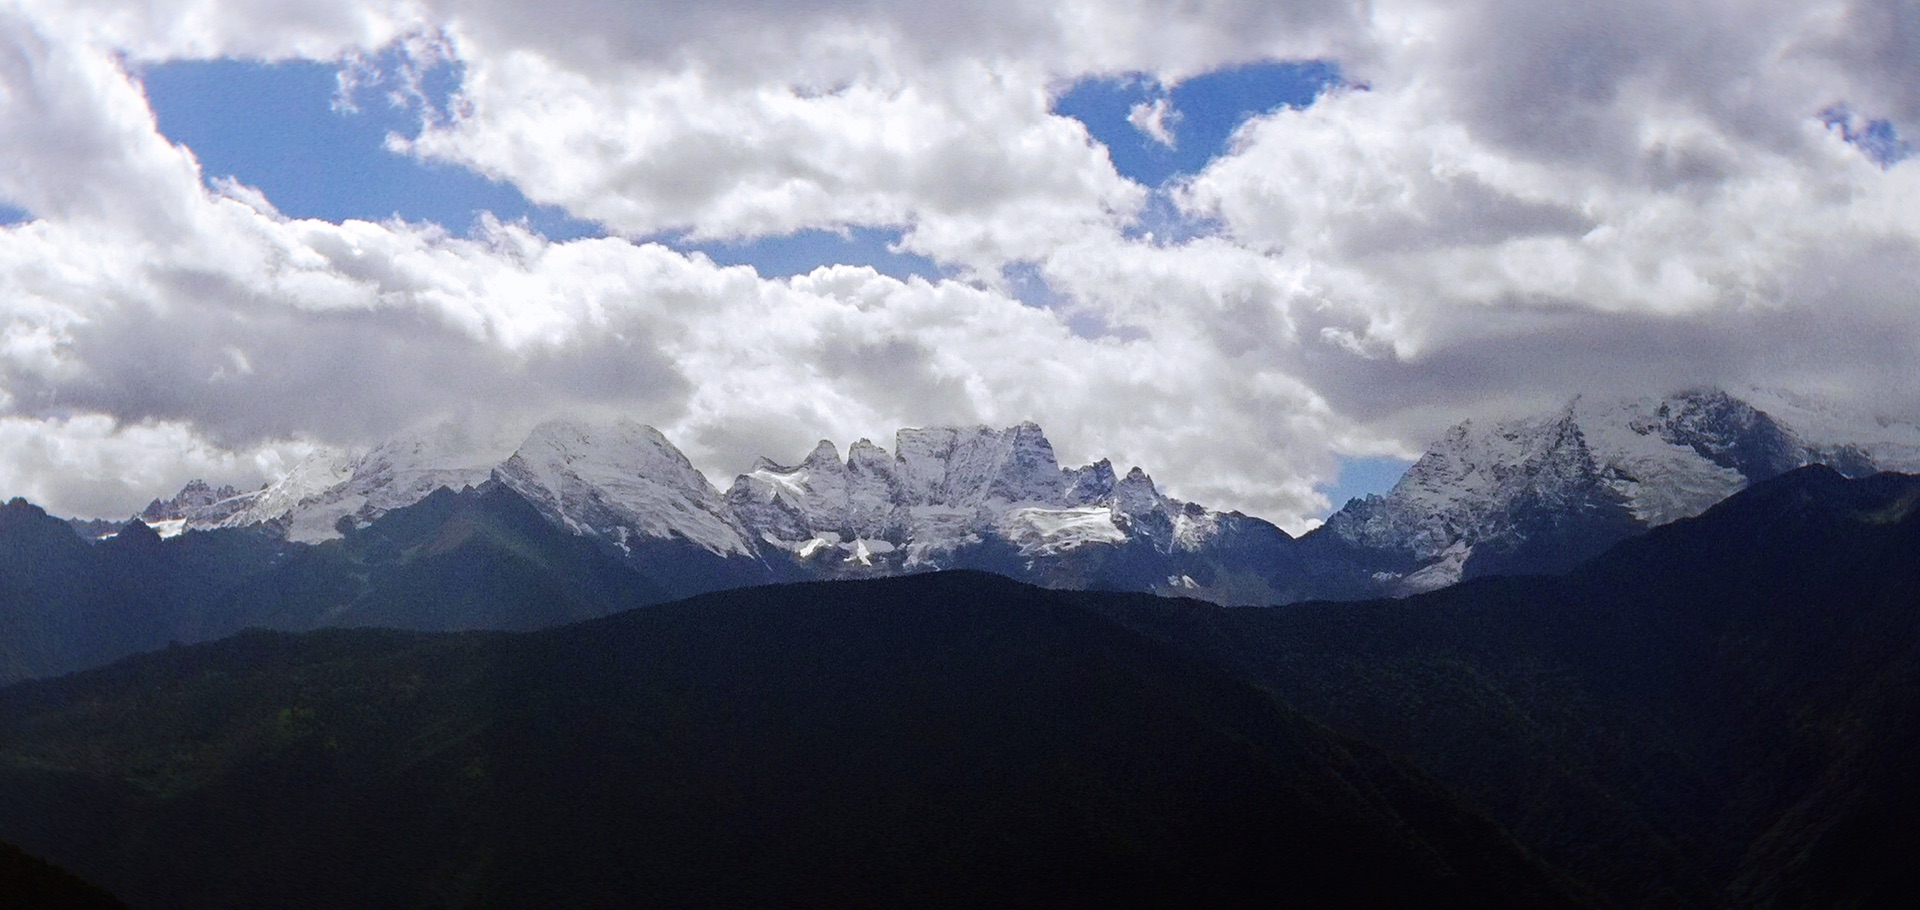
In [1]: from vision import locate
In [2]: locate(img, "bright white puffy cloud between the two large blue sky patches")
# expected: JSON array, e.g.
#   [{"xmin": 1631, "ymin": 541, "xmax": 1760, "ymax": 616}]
[{"xmin": 393, "ymin": 54, "xmax": 1142, "ymax": 271}]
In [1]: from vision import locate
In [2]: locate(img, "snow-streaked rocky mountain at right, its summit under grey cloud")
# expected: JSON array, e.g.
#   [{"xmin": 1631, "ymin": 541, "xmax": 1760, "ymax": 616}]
[{"xmin": 1306, "ymin": 390, "xmax": 1920, "ymax": 593}]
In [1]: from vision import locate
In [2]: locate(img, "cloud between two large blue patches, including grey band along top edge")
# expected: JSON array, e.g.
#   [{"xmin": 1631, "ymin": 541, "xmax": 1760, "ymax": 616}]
[{"xmin": 15, "ymin": 0, "xmax": 1359, "ymax": 275}]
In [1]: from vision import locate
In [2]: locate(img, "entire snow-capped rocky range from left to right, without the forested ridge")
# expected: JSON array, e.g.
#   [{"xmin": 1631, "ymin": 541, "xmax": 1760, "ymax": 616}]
[{"xmin": 123, "ymin": 390, "xmax": 1920, "ymax": 603}]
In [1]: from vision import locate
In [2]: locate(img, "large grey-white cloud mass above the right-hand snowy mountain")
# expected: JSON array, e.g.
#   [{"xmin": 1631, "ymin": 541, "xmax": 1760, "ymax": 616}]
[{"xmin": 1179, "ymin": 2, "xmax": 1920, "ymax": 436}]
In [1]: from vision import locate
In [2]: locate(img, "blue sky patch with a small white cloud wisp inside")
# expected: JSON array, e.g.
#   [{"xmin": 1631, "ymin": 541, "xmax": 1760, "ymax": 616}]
[{"xmin": 1054, "ymin": 60, "xmax": 1340, "ymax": 186}]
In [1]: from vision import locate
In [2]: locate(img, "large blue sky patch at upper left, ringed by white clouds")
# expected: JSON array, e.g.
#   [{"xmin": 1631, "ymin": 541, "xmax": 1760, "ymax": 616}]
[{"xmin": 140, "ymin": 60, "xmax": 601, "ymax": 240}]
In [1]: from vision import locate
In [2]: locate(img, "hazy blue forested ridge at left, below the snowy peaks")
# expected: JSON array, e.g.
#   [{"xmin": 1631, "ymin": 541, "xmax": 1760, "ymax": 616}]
[{"xmin": 0, "ymin": 484, "xmax": 687, "ymax": 682}]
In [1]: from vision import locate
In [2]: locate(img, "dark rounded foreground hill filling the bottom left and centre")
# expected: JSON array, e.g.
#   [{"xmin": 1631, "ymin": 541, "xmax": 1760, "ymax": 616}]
[{"xmin": 0, "ymin": 574, "xmax": 1569, "ymax": 908}]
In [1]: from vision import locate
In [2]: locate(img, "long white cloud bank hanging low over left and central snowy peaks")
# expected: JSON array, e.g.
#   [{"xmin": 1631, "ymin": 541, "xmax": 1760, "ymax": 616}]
[{"xmin": 0, "ymin": 10, "xmax": 1359, "ymax": 518}]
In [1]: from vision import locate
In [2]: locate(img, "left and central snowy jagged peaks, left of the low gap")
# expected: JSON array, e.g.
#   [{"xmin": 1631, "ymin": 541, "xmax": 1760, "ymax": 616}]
[{"xmin": 140, "ymin": 420, "xmax": 1286, "ymax": 589}]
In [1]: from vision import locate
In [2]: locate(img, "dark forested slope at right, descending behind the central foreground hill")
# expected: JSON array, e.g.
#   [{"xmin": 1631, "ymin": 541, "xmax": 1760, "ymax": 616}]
[{"xmin": 1112, "ymin": 467, "xmax": 1920, "ymax": 906}]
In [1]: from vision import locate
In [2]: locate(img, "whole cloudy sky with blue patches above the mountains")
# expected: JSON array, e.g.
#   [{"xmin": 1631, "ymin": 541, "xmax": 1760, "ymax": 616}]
[{"xmin": 0, "ymin": 0, "xmax": 1920, "ymax": 532}]
